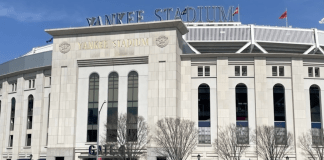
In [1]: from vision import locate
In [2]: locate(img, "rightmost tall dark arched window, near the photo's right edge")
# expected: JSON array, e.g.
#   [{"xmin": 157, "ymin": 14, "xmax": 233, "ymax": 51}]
[{"xmin": 309, "ymin": 85, "xmax": 323, "ymax": 144}]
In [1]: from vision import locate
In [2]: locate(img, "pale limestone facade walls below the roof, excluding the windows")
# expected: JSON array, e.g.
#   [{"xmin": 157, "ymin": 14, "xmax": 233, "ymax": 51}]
[{"xmin": 0, "ymin": 21, "xmax": 324, "ymax": 160}]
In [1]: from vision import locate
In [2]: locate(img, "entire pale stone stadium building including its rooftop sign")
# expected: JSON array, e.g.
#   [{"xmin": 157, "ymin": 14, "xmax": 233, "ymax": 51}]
[{"xmin": 0, "ymin": 6, "xmax": 324, "ymax": 160}]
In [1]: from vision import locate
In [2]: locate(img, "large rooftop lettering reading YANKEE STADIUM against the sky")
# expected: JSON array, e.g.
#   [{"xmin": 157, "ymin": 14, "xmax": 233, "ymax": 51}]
[{"xmin": 87, "ymin": 6, "xmax": 239, "ymax": 26}]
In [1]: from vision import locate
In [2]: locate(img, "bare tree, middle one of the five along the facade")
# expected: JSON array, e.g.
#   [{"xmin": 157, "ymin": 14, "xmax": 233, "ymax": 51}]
[{"xmin": 213, "ymin": 124, "xmax": 249, "ymax": 160}]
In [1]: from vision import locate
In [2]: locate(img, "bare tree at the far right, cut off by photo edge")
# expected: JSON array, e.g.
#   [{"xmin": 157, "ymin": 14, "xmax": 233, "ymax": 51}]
[{"xmin": 298, "ymin": 129, "xmax": 324, "ymax": 160}]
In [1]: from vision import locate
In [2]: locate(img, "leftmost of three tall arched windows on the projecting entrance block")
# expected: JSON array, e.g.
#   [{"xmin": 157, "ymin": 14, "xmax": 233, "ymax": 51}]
[{"xmin": 87, "ymin": 73, "xmax": 99, "ymax": 142}]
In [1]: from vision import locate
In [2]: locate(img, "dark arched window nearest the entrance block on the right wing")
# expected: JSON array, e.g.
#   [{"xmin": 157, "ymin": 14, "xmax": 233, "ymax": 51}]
[{"xmin": 198, "ymin": 84, "xmax": 210, "ymax": 144}]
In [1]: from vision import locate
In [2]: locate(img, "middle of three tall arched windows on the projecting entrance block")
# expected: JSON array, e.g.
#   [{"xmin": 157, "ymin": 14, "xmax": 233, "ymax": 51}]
[{"xmin": 107, "ymin": 72, "xmax": 118, "ymax": 142}]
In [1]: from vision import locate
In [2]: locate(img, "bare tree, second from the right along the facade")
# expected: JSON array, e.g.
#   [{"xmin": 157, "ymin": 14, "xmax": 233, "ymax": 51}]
[{"xmin": 252, "ymin": 125, "xmax": 293, "ymax": 160}]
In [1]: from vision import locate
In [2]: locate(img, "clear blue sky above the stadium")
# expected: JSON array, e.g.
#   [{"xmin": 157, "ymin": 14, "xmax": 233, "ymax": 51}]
[{"xmin": 0, "ymin": 0, "xmax": 324, "ymax": 63}]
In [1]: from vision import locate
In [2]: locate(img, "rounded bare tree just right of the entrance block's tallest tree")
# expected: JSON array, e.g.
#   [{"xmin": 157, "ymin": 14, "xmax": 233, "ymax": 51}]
[{"xmin": 154, "ymin": 118, "xmax": 198, "ymax": 160}]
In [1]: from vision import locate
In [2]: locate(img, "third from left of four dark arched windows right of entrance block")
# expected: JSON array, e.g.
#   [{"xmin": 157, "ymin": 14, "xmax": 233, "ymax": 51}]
[{"xmin": 273, "ymin": 84, "xmax": 287, "ymax": 144}]
